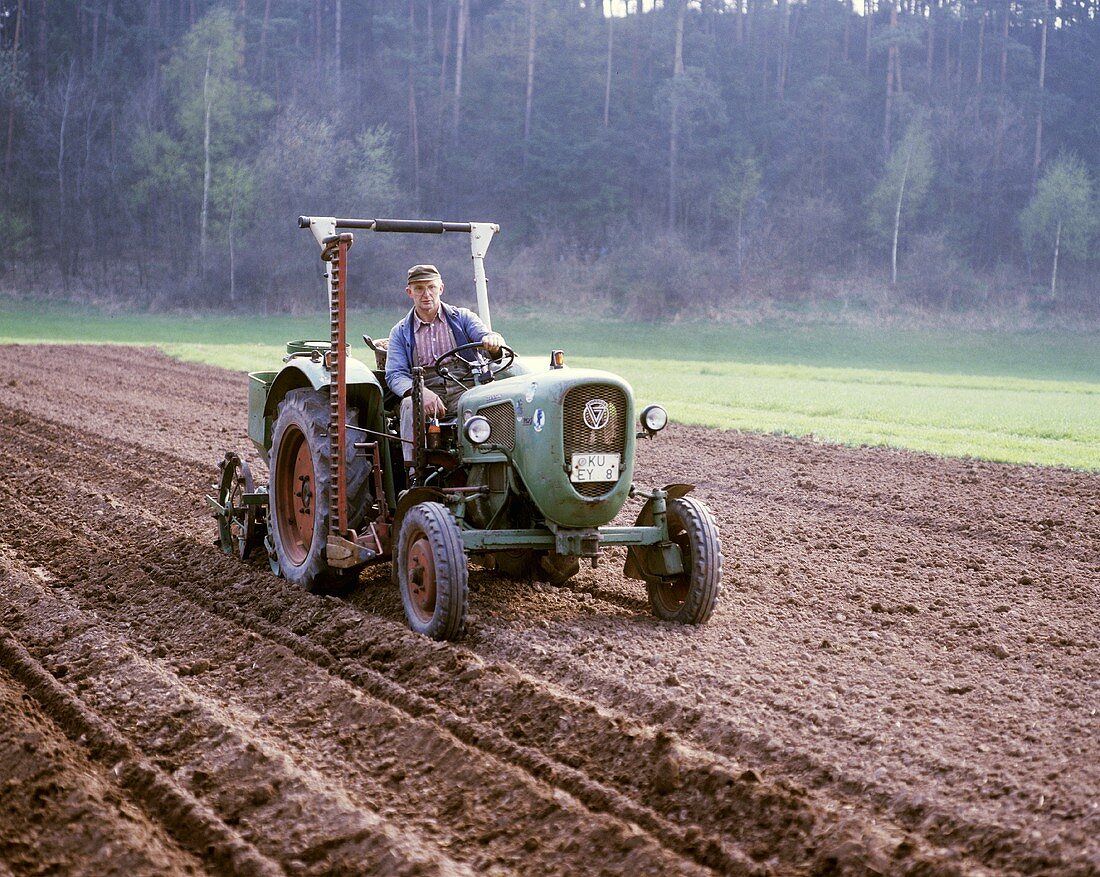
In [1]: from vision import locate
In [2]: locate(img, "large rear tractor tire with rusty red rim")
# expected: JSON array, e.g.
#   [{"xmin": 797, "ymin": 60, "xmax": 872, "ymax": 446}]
[{"xmin": 267, "ymin": 387, "xmax": 370, "ymax": 593}]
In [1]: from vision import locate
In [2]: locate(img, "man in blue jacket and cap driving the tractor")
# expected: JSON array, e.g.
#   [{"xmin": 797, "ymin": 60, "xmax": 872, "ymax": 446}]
[{"xmin": 385, "ymin": 265, "xmax": 505, "ymax": 463}]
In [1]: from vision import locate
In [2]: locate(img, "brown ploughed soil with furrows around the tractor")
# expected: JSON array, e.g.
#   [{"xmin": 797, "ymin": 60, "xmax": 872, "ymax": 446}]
[{"xmin": 0, "ymin": 347, "xmax": 1100, "ymax": 875}]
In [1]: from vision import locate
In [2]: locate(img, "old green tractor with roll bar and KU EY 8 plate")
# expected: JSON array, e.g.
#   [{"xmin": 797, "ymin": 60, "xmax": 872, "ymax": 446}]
[{"xmin": 207, "ymin": 217, "xmax": 722, "ymax": 639}]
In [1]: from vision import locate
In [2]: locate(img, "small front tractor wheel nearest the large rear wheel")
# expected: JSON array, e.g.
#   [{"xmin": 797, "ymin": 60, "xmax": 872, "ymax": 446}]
[{"xmin": 394, "ymin": 503, "xmax": 470, "ymax": 639}]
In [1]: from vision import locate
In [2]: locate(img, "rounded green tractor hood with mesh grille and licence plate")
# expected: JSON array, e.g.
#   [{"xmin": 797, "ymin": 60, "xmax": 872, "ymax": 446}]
[{"xmin": 459, "ymin": 368, "xmax": 636, "ymax": 527}]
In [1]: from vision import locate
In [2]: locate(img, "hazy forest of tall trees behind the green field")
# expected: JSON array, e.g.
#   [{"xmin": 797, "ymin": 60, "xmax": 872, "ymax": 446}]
[{"xmin": 0, "ymin": 0, "xmax": 1100, "ymax": 319}]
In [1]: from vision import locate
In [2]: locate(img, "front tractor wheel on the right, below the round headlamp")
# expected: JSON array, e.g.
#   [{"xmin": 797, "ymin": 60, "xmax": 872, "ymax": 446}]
[{"xmin": 647, "ymin": 497, "xmax": 722, "ymax": 624}]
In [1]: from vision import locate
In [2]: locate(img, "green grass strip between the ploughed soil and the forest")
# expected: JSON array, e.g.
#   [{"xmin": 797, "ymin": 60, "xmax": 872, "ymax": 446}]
[{"xmin": 0, "ymin": 300, "xmax": 1100, "ymax": 470}]
